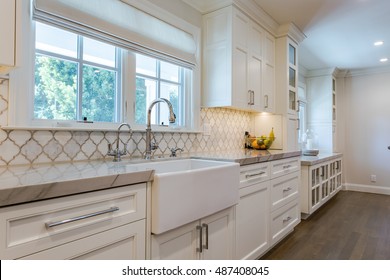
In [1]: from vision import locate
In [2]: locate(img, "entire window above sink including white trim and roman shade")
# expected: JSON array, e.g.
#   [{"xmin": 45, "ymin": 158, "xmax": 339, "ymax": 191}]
[{"xmin": 8, "ymin": 0, "xmax": 200, "ymax": 131}]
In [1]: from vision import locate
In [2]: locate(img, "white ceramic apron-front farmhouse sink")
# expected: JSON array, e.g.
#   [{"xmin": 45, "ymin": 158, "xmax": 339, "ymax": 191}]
[{"xmin": 128, "ymin": 159, "xmax": 240, "ymax": 234}]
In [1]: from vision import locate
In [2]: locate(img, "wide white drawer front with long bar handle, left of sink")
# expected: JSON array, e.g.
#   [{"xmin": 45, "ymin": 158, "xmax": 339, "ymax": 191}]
[{"xmin": 0, "ymin": 184, "xmax": 146, "ymax": 259}]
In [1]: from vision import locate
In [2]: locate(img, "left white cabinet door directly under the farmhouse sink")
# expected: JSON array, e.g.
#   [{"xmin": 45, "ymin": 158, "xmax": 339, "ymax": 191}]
[{"xmin": 151, "ymin": 221, "xmax": 201, "ymax": 260}]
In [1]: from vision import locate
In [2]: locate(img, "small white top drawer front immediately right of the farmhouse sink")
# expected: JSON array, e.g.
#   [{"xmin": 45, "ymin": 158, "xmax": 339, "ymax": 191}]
[{"xmin": 240, "ymin": 162, "xmax": 271, "ymax": 188}]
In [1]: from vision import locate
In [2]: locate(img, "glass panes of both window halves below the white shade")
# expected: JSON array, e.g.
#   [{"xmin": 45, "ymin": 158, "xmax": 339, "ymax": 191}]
[{"xmin": 34, "ymin": 22, "xmax": 191, "ymax": 129}]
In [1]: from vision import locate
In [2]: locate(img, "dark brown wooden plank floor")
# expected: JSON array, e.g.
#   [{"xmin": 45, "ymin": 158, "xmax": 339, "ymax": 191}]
[{"xmin": 261, "ymin": 191, "xmax": 390, "ymax": 260}]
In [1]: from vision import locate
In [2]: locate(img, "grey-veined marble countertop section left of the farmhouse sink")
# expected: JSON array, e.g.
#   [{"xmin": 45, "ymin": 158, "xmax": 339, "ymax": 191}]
[{"xmin": 0, "ymin": 161, "xmax": 154, "ymax": 207}]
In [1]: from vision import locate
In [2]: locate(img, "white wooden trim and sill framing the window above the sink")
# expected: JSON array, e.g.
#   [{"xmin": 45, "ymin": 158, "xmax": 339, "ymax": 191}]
[{"xmin": 7, "ymin": 1, "xmax": 201, "ymax": 132}]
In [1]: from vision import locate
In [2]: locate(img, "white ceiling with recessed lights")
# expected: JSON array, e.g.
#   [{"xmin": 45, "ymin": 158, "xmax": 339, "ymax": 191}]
[{"xmin": 254, "ymin": 0, "xmax": 390, "ymax": 70}]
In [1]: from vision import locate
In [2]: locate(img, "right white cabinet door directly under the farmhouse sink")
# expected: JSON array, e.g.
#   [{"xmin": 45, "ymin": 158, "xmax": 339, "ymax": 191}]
[{"xmin": 201, "ymin": 208, "xmax": 234, "ymax": 260}]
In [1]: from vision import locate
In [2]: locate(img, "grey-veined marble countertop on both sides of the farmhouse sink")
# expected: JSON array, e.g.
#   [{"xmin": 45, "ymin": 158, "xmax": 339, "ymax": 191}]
[{"xmin": 0, "ymin": 149, "xmax": 301, "ymax": 207}]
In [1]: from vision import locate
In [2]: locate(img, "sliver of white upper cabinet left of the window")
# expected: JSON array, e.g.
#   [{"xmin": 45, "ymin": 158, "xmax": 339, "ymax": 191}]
[{"xmin": 0, "ymin": 0, "xmax": 16, "ymax": 74}]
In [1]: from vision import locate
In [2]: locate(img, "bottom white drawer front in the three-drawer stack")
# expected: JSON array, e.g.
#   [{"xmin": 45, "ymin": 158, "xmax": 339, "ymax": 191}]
[{"xmin": 270, "ymin": 200, "xmax": 301, "ymax": 246}]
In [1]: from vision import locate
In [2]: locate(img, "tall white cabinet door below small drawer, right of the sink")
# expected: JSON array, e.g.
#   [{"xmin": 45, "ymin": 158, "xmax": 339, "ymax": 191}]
[{"xmin": 235, "ymin": 181, "xmax": 269, "ymax": 260}]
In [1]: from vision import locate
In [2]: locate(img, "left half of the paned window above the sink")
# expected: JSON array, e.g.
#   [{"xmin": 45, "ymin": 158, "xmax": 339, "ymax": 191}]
[{"xmin": 34, "ymin": 22, "xmax": 121, "ymax": 122}]
